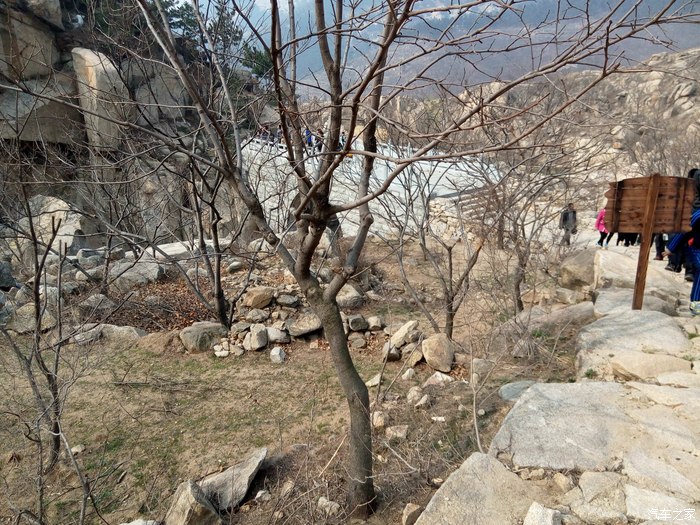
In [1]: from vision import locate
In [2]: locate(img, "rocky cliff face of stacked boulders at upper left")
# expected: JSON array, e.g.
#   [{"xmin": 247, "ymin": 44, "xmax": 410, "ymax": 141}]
[{"xmin": 0, "ymin": 0, "xmax": 201, "ymax": 239}]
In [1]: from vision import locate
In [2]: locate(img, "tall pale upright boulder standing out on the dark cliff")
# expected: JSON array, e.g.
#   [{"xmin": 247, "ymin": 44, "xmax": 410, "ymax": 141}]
[{"xmin": 71, "ymin": 47, "xmax": 132, "ymax": 149}]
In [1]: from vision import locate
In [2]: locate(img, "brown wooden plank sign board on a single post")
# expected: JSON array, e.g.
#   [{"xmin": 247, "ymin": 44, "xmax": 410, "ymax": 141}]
[{"xmin": 605, "ymin": 173, "xmax": 695, "ymax": 310}]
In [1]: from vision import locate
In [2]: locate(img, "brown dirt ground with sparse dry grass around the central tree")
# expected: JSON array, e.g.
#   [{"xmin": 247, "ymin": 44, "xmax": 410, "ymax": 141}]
[{"xmin": 0, "ymin": 239, "xmax": 575, "ymax": 525}]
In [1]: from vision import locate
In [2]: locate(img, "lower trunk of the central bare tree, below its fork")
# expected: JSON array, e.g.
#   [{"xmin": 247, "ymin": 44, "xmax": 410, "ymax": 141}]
[{"xmin": 309, "ymin": 298, "xmax": 376, "ymax": 518}]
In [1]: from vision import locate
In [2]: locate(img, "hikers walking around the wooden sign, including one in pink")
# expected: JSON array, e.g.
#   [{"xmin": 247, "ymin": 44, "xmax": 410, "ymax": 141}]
[{"xmin": 559, "ymin": 168, "xmax": 700, "ymax": 316}]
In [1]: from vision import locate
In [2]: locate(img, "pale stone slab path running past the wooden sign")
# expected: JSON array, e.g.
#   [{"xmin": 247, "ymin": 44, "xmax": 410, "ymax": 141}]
[{"xmin": 416, "ymin": 243, "xmax": 700, "ymax": 525}]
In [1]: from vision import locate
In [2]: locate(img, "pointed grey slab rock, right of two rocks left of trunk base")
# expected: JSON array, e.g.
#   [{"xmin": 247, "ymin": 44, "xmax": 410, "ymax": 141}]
[{"xmin": 200, "ymin": 448, "xmax": 267, "ymax": 511}]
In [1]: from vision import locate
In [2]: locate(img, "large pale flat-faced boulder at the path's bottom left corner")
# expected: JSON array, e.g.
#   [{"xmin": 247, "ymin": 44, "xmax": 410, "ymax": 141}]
[{"xmin": 416, "ymin": 452, "xmax": 544, "ymax": 525}]
